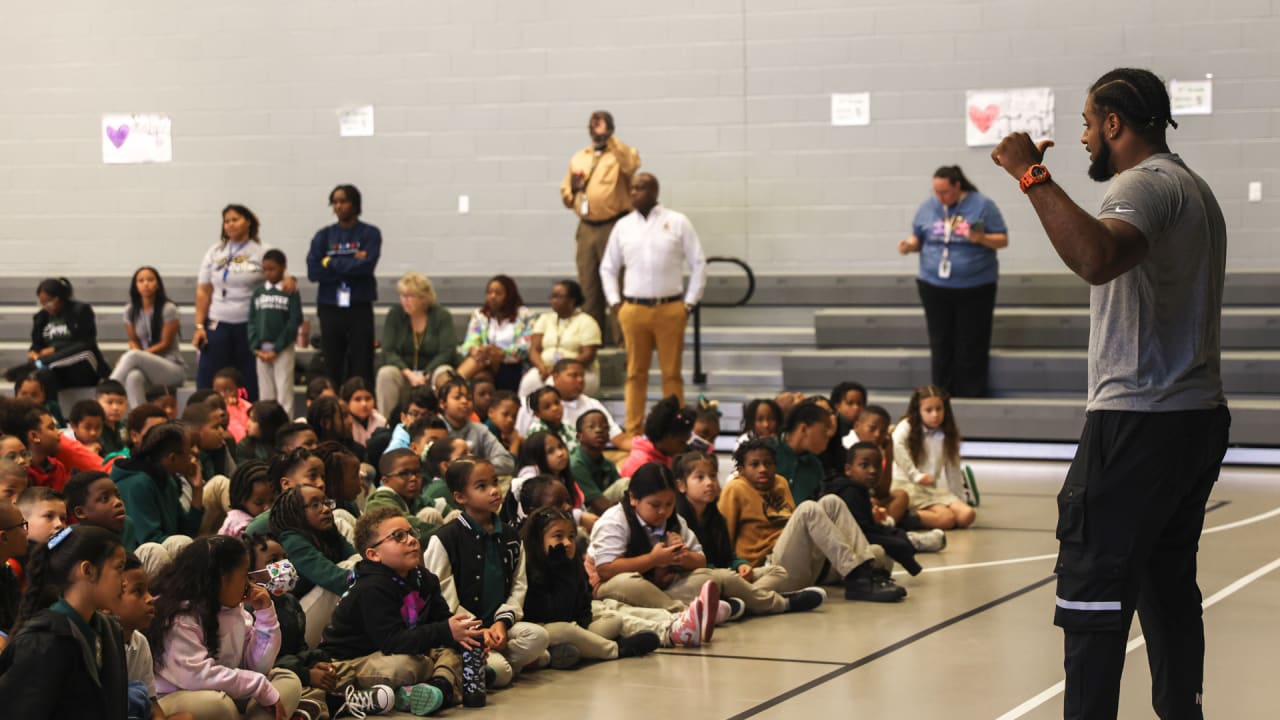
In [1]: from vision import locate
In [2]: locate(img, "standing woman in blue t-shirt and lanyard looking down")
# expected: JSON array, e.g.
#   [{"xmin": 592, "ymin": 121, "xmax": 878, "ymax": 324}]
[{"xmin": 897, "ymin": 165, "xmax": 1009, "ymax": 397}]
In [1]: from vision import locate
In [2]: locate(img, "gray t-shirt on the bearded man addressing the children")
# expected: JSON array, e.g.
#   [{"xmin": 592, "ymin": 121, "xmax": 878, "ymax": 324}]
[{"xmin": 1088, "ymin": 154, "xmax": 1226, "ymax": 413}]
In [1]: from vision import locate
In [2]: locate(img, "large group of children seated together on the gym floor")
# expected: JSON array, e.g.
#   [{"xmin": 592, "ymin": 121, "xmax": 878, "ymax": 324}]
[{"xmin": 0, "ymin": 359, "xmax": 977, "ymax": 720}]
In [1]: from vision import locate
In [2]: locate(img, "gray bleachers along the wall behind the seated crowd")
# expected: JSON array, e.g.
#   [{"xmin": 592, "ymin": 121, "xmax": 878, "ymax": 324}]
[{"xmin": 0, "ymin": 273, "xmax": 1280, "ymax": 447}]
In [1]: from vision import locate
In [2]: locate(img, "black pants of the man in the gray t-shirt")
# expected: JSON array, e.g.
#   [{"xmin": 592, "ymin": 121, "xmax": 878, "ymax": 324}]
[{"xmin": 1053, "ymin": 406, "xmax": 1231, "ymax": 720}]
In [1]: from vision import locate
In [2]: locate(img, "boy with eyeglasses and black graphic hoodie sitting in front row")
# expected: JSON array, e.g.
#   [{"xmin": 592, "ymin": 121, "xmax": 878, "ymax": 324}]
[{"xmin": 320, "ymin": 504, "xmax": 483, "ymax": 716}]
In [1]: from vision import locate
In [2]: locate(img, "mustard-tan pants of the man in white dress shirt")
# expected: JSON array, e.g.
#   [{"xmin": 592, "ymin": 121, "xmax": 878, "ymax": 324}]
[{"xmin": 618, "ymin": 300, "xmax": 689, "ymax": 436}]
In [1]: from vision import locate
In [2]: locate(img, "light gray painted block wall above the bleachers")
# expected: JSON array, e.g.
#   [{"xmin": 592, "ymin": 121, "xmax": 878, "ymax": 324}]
[{"xmin": 0, "ymin": 0, "xmax": 1280, "ymax": 274}]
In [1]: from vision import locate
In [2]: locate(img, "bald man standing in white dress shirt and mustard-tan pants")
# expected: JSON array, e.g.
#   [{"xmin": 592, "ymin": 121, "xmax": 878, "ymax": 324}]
[{"xmin": 600, "ymin": 173, "xmax": 707, "ymax": 436}]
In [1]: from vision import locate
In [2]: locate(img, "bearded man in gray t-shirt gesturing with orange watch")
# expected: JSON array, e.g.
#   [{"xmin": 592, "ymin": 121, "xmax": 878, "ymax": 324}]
[{"xmin": 991, "ymin": 68, "xmax": 1230, "ymax": 719}]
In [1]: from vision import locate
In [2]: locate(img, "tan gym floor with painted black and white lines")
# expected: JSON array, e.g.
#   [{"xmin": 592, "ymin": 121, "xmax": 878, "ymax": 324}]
[{"xmin": 435, "ymin": 461, "xmax": 1280, "ymax": 720}]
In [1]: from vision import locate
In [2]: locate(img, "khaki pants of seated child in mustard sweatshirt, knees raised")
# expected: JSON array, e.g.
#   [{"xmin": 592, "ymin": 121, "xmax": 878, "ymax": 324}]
[{"xmin": 760, "ymin": 495, "xmax": 893, "ymax": 592}]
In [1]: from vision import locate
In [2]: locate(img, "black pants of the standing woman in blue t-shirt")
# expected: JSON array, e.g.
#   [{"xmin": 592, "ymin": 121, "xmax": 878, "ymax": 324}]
[{"xmin": 915, "ymin": 279, "xmax": 996, "ymax": 397}]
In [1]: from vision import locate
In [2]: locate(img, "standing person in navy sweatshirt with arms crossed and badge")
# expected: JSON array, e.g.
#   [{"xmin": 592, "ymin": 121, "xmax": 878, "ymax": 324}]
[{"xmin": 307, "ymin": 184, "xmax": 378, "ymax": 386}]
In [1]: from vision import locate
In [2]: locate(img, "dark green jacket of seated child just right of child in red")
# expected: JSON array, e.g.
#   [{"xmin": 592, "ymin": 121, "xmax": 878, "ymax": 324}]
[{"xmin": 111, "ymin": 459, "xmax": 205, "ymax": 552}]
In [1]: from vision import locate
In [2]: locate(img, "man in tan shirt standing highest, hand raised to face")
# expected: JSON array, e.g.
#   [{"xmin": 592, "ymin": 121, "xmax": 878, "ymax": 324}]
[{"xmin": 561, "ymin": 110, "xmax": 640, "ymax": 342}]
